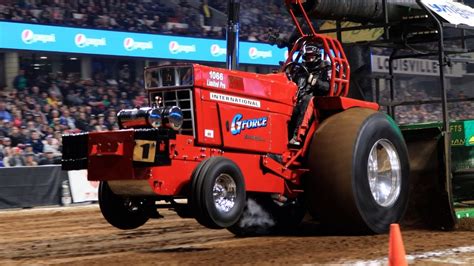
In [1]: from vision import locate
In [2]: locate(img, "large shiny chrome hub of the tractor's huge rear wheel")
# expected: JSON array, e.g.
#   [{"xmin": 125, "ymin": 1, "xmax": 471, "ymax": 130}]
[{"xmin": 368, "ymin": 139, "xmax": 402, "ymax": 207}]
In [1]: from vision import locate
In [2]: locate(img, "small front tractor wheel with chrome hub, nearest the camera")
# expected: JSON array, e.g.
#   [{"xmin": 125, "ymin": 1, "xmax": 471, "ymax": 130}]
[{"xmin": 189, "ymin": 157, "xmax": 246, "ymax": 229}]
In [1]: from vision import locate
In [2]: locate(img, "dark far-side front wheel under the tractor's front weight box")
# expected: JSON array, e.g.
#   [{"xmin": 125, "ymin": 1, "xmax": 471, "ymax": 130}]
[{"xmin": 99, "ymin": 181, "xmax": 149, "ymax": 230}]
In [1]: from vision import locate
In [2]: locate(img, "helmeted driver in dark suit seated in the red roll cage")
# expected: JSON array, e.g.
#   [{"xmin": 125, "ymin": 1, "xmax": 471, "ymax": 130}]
[{"xmin": 290, "ymin": 44, "xmax": 331, "ymax": 145}]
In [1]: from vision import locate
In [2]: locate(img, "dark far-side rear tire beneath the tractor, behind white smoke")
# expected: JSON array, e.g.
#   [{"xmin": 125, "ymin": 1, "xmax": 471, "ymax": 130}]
[{"xmin": 227, "ymin": 193, "xmax": 306, "ymax": 237}]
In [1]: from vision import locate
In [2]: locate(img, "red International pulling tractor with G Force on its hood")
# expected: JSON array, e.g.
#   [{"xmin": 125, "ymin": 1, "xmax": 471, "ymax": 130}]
[{"xmin": 63, "ymin": 0, "xmax": 409, "ymax": 235}]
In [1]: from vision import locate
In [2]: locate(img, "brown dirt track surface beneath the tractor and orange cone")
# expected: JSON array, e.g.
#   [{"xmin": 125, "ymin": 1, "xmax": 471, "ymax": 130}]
[{"xmin": 0, "ymin": 205, "xmax": 474, "ymax": 265}]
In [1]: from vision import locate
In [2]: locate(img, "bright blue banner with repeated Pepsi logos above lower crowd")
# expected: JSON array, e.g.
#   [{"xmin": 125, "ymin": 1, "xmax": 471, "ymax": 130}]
[{"xmin": 0, "ymin": 22, "xmax": 286, "ymax": 65}]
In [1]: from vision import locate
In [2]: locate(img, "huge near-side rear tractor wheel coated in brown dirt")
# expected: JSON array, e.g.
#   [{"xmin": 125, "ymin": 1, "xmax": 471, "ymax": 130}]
[{"xmin": 305, "ymin": 108, "xmax": 409, "ymax": 234}]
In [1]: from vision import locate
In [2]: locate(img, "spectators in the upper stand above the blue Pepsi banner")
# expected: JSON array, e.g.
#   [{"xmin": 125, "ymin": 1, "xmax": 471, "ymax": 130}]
[{"xmin": 0, "ymin": 0, "xmax": 293, "ymax": 41}]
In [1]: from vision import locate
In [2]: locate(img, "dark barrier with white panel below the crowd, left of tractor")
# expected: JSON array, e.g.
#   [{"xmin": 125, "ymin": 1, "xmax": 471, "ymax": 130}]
[{"xmin": 0, "ymin": 165, "xmax": 98, "ymax": 209}]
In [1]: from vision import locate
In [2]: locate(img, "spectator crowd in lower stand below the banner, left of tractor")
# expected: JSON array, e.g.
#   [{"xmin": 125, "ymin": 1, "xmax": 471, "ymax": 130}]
[{"xmin": 0, "ymin": 68, "xmax": 148, "ymax": 167}]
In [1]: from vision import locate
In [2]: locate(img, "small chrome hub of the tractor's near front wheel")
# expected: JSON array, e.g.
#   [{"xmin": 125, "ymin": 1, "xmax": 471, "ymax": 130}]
[{"xmin": 212, "ymin": 174, "xmax": 237, "ymax": 212}]
